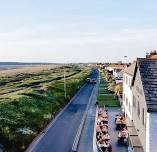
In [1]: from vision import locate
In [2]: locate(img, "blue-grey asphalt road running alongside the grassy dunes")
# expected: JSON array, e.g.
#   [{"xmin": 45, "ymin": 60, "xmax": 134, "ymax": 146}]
[{"xmin": 27, "ymin": 70, "xmax": 98, "ymax": 152}]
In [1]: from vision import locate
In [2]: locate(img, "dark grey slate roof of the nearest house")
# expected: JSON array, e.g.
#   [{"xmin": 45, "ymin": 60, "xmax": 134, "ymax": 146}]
[{"xmin": 133, "ymin": 58, "xmax": 157, "ymax": 112}]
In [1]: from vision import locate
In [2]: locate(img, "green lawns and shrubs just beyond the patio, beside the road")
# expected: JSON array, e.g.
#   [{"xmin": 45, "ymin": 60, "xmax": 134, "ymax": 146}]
[{"xmin": 98, "ymin": 72, "xmax": 121, "ymax": 107}]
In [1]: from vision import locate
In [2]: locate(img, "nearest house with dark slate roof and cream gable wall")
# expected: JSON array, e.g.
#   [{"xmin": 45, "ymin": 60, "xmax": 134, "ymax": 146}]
[{"xmin": 132, "ymin": 58, "xmax": 157, "ymax": 152}]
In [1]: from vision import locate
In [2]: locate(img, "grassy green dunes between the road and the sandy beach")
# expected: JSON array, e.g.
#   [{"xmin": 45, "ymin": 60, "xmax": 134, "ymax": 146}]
[{"xmin": 0, "ymin": 66, "xmax": 91, "ymax": 152}]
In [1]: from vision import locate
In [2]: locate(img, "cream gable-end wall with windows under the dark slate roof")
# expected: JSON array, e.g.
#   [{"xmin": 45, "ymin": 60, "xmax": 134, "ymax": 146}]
[{"xmin": 132, "ymin": 69, "xmax": 149, "ymax": 152}]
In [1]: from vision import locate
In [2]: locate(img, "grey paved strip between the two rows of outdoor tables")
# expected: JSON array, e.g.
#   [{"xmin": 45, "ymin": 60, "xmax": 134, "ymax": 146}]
[{"xmin": 108, "ymin": 108, "xmax": 127, "ymax": 152}]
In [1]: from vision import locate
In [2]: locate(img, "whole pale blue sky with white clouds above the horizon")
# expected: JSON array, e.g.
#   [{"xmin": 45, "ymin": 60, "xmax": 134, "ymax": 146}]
[{"xmin": 0, "ymin": 0, "xmax": 157, "ymax": 63}]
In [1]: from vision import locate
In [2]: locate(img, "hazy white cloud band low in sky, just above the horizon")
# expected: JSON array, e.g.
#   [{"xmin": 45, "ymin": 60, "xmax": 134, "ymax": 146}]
[{"xmin": 0, "ymin": 24, "xmax": 157, "ymax": 62}]
